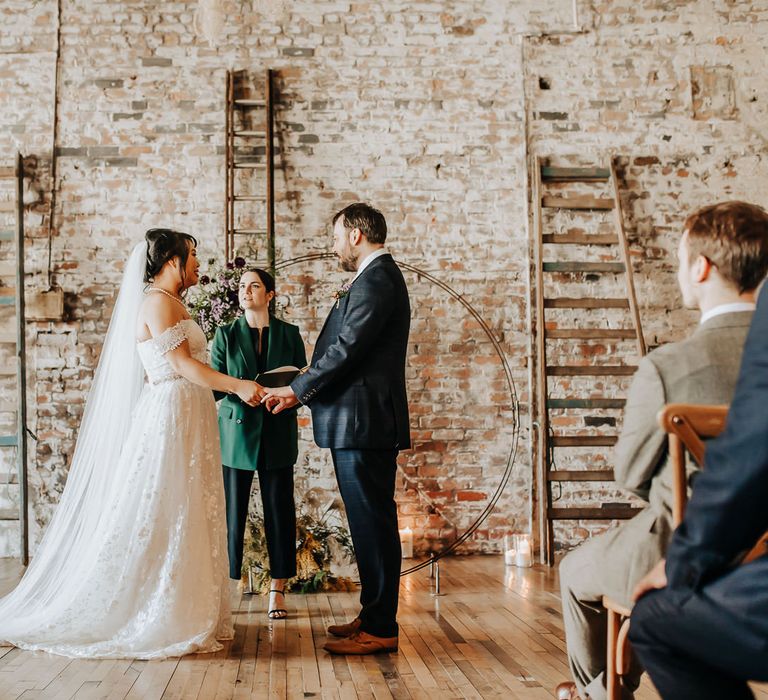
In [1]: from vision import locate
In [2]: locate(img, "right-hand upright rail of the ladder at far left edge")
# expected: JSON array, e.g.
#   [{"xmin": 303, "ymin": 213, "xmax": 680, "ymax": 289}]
[{"xmin": 16, "ymin": 153, "xmax": 28, "ymax": 566}]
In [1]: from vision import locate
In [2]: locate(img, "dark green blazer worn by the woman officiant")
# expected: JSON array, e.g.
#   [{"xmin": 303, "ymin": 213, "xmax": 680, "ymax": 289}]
[{"xmin": 211, "ymin": 316, "xmax": 307, "ymax": 471}]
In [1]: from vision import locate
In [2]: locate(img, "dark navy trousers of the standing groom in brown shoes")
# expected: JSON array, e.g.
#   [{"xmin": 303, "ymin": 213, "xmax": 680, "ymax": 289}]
[{"xmin": 331, "ymin": 449, "xmax": 402, "ymax": 637}]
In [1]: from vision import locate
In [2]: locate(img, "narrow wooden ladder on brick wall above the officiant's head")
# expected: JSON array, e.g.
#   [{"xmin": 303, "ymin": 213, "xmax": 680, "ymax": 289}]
[{"xmin": 224, "ymin": 68, "xmax": 275, "ymax": 275}]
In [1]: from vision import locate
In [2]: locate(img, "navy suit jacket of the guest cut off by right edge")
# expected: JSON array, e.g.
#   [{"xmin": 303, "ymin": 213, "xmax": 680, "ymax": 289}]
[{"xmin": 667, "ymin": 289, "xmax": 768, "ymax": 616}]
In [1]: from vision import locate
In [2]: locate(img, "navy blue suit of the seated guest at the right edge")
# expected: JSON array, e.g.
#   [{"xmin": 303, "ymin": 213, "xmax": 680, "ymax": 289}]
[{"xmin": 630, "ymin": 290, "xmax": 768, "ymax": 700}]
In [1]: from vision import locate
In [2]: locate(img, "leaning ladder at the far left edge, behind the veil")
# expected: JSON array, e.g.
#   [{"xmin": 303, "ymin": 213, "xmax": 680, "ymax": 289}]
[{"xmin": 0, "ymin": 154, "xmax": 29, "ymax": 566}]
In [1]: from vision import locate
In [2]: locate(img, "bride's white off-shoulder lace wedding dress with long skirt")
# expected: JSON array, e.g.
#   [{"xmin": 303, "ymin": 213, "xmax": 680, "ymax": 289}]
[{"xmin": 0, "ymin": 245, "xmax": 233, "ymax": 659}]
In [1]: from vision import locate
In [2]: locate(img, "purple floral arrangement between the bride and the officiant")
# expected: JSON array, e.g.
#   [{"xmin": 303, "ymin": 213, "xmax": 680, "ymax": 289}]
[{"xmin": 187, "ymin": 257, "xmax": 246, "ymax": 340}]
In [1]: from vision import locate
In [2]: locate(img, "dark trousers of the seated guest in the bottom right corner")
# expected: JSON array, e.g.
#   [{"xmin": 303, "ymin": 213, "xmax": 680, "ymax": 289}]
[{"xmin": 629, "ymin": 566, "xmax": 768, "ymax": 700}]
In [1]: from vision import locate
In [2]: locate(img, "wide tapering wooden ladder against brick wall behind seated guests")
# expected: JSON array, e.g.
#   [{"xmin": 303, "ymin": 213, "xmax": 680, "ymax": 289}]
[{"xmin": 533, "ymin": 158, "xmax": 645, "ymax": 565}]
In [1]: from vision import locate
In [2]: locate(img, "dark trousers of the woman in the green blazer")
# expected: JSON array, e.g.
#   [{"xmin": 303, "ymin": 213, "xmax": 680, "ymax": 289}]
[{"xmin": 223, "ymin": 465, "xmax": 296, "ymax": 579}]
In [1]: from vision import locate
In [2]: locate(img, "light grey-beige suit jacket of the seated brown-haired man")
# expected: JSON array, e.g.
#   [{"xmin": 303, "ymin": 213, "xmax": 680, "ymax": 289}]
[{"xmin": 583, "ymin": 311, "xmax": 752, "ymax": 603}]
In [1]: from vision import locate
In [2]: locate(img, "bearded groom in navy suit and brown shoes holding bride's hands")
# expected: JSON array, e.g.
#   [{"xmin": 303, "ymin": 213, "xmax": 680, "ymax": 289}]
[{"xmin": 264, "ymin": 203, "xmax": 411, "ymax": 654}]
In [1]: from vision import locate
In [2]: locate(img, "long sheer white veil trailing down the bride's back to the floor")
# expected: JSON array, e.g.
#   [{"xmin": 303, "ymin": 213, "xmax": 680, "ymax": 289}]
[{"xmin": 0, "ymin": 242, "xmax": 147, "ymax": 640}]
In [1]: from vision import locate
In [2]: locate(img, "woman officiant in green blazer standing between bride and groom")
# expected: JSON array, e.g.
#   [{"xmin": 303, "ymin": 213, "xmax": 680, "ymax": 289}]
[{"xmin": 211, "ymin": 269, "xmax": 307, "ymax": 619}]
